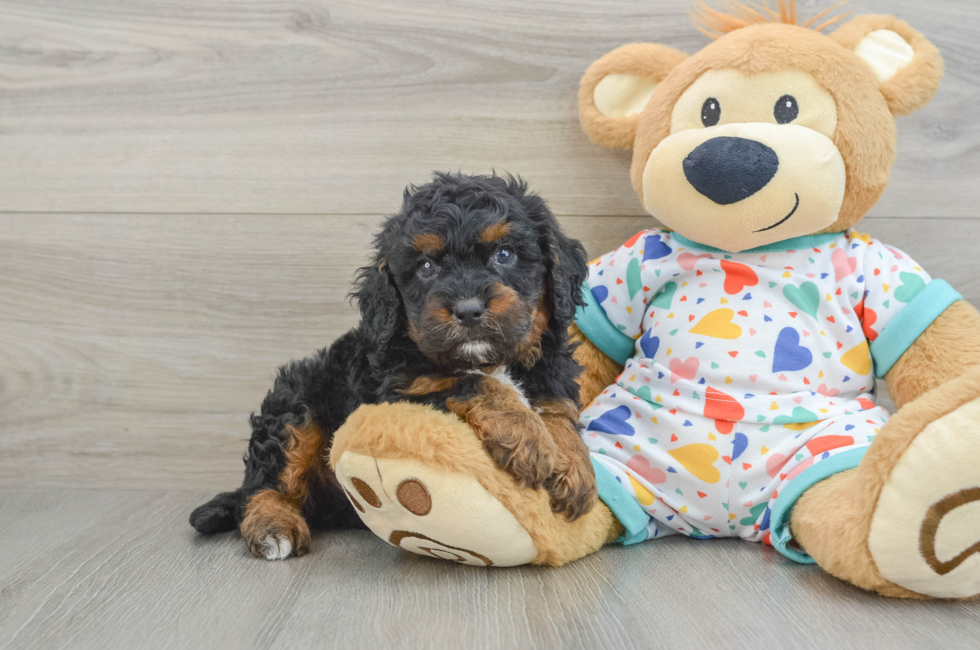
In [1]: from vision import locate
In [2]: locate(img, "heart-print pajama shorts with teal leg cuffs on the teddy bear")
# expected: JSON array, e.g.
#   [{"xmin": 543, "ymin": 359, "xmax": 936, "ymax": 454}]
[{"xmin": 582, "ymin": 359, "xmax": 888, "ymax": 562}]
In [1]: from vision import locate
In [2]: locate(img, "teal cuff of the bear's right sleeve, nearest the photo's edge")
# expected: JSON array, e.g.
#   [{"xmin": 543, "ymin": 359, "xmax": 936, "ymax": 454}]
[{"xmin": 871, "ymin": 280, "xmax": 963, "ymax": 378}]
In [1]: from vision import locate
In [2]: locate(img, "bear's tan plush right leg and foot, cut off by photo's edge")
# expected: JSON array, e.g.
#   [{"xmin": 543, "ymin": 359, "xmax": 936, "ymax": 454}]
[{"xmin": 791, "ymin": 368, "xmax": 980, "ymax": 599}]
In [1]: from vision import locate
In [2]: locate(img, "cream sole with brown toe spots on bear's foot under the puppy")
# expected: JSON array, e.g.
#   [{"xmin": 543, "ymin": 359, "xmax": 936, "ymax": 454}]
[{"xmin": 336, "ymin": 451, "xmax": 537, "ymax": 566}]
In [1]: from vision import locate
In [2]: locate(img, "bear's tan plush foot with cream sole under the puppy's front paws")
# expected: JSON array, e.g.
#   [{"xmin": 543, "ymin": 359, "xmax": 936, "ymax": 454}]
[{"xmin": 330, "ymin": 403, "xmax": 622, "ymax": 566}]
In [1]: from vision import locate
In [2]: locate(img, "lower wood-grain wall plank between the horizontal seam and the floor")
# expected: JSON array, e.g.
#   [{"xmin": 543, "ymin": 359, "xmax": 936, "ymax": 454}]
[{"xmin": 0, "ymin": 215, "xmax": 980, "ymax": 489}]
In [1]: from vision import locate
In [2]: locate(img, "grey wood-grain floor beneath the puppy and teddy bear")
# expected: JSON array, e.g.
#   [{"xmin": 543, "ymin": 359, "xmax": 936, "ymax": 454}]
[{"xmin": 0, "ymin": 490, "xmax": 980, "ymax": 650}]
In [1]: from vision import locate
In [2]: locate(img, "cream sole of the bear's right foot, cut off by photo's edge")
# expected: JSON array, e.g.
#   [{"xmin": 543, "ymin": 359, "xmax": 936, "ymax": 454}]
[{"xmin": 868, "ymin": 392, "xmax": 980, "ymax": 598}]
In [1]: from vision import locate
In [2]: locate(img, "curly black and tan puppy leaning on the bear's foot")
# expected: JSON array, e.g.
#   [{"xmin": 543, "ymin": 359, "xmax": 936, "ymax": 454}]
[{"xmin": 190, "ymin": 174, "xmax": 596, "ymax": 559}]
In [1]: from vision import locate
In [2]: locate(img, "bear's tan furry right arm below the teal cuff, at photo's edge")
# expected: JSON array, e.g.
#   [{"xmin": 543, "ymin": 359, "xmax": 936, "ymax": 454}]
[{"xmin": 884, "ymin": 300, "xmax": 980, "ymax": 408}]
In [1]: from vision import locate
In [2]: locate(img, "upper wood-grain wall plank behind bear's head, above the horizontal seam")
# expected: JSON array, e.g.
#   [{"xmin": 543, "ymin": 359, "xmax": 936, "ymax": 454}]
[{"xmin": 0, "ymin": 0, "xmax": 980, "ymax": 217}]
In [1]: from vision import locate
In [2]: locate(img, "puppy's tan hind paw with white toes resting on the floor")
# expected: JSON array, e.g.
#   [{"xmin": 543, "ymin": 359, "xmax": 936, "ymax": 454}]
[{"xmin": 241, "ymin": 490, "xmax": 310, "ymax": 560}]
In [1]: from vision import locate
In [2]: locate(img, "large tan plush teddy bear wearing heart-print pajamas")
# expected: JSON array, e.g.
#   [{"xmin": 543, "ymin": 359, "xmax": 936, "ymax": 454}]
[{"xmin": 330, "ymin": 2, "xmax": 980, "ymax": 598}]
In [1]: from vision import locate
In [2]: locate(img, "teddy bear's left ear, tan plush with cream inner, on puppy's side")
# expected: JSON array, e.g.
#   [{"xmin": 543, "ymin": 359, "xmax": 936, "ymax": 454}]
[{"xmin": 578, "ymin": 43, "xmax": 687, "ymax": 149}]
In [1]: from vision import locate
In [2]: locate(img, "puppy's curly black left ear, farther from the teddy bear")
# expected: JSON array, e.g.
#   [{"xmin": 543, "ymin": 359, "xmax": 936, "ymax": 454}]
[{"xmin": 351, "ymin": 216, "xmax": 402, "ymax": 347}]
